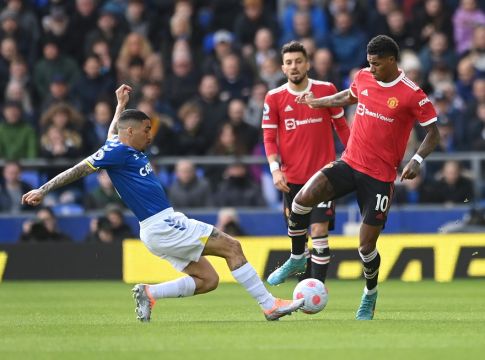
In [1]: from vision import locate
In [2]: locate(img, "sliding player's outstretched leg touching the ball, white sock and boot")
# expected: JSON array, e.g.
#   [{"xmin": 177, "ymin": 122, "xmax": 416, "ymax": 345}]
[{"xmin": 203, "ymin": 228, "xmax": 303, "ymax": 321}]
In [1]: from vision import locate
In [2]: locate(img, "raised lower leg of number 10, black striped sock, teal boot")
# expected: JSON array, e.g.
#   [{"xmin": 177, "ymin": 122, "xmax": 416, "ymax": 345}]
[{"xmin": 268, "ymin": 201, "xmax": 312, "ymax": 285}]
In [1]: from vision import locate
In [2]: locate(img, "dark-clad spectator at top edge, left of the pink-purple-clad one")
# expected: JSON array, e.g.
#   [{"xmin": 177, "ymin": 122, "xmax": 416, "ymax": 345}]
[{"xmin": 411, "ymin": 0, "xmax": 454, "ymax": 49}]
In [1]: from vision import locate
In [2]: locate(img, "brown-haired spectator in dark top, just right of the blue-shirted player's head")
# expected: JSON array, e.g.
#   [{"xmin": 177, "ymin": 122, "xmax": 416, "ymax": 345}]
[{"xmin": 175, "ymin": 101, "xmax": 210, "ymax": 156}]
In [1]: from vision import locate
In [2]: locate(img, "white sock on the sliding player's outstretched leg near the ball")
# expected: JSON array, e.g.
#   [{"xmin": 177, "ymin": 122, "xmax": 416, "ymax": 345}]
[{"xmin": 232, "ymin": 263, "xmax": 275, "ymax": 310}]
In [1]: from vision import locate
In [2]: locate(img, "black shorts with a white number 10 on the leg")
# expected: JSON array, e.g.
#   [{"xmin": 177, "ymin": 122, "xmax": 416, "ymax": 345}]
[{"xmin": 321, "ymin": 160, "xmax": 394, "ymax": 226}]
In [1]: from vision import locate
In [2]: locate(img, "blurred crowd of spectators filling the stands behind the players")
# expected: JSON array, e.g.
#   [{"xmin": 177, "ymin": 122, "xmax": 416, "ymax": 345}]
[{"xmin": 0, "ymin": 0, "xmax": 485, "ymax": 226}]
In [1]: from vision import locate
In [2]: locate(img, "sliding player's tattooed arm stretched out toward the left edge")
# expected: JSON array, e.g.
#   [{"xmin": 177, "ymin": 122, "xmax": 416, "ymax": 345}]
[{"xmin": 22, "ymin": 160, "xmax": 96, "ymax": 206}]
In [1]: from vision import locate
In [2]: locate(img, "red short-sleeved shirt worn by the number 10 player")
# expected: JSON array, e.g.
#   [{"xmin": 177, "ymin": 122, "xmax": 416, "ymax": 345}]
[{"xmin": 342, "ymin": 68, "xmax": 437, "ymax": 182}]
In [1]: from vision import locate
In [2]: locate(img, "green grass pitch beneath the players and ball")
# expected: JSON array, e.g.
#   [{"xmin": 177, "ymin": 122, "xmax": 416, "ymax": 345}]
[{"xmin": 0, "ymin": 280, "xmax": 485, "ymax": 360}]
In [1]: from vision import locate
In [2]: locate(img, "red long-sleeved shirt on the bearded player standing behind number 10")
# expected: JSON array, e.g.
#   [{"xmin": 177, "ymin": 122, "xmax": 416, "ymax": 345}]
[{"xmin": 262, "ymin": 79, "xmax": 349, "ymax": 184}]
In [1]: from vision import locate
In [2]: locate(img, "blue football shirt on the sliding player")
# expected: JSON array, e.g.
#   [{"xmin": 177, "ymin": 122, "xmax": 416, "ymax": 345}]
[{"xmin": 85, "ymin": 136, "xmax": 171, "ymax": 221}]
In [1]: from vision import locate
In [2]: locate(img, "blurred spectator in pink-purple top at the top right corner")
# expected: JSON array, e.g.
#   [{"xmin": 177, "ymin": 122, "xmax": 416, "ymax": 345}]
[{"xmin": 453, "ymin": 0, "xmax": 485, "ymax": 54}]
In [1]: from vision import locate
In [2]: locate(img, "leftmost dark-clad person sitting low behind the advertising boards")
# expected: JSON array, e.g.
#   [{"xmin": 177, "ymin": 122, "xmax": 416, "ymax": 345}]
[{"xmin": 20, "ymin": 207, "xmax": 71, "ymax": 242}]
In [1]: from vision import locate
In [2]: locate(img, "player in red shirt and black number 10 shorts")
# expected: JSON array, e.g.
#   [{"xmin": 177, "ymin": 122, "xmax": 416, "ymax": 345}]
[{"xmin": 289, "ymin": 35, "xmax": 439, "ymax": 320}]
